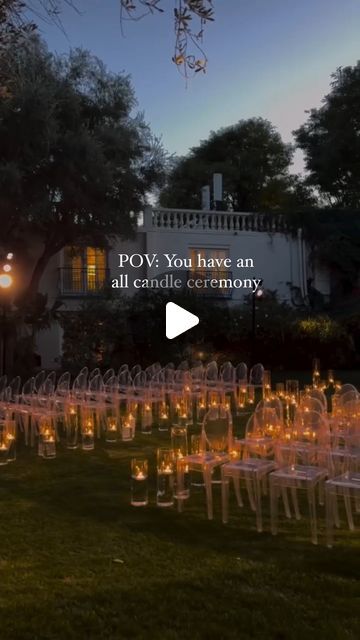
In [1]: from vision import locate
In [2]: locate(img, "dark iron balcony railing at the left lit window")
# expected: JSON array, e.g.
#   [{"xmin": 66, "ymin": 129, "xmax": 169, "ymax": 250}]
[{"xmin": 59, "ymin": 267, "xmax": 109, "ymax": 296}]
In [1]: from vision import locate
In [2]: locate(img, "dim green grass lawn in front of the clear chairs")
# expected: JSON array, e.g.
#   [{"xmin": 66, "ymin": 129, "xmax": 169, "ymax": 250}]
[{"xmin": 0, "ymin": 422, "xmax": 360, "ymax": 640}]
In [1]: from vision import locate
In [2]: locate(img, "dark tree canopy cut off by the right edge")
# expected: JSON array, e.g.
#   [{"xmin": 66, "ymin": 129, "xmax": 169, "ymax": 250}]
[{"xmin": 294, "ymin": 62, "xmax": 360, "ymax": 208}]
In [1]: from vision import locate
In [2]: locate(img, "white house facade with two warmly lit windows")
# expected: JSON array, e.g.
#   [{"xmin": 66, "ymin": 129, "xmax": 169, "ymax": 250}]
[{"xmin": 37, "ymin": 207, "xmax": 329, "ymax": 369}]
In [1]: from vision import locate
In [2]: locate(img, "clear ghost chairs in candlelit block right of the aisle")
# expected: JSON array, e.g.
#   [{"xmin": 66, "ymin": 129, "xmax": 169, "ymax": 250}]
[{"xmin": 178, "ymin": 385, "xmax": 360, "ymax": 546}]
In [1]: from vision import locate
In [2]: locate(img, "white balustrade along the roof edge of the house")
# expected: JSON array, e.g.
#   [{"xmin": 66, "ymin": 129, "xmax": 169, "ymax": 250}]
[{"xmin": 144, "ymin": 207, "xmax": 286, "ymax": 233}]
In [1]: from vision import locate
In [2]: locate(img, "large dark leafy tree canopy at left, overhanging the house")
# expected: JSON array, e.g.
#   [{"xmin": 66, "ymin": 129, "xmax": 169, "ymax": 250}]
[{"xmin": 0, "ymin": 37, "xmax": 165, "ymax": 300}]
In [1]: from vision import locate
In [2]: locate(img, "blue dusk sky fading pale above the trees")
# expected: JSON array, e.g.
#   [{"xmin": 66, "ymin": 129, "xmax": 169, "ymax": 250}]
[{"xmin": 40, "ymin": 0, "xmax": 360, "ymax": 170}]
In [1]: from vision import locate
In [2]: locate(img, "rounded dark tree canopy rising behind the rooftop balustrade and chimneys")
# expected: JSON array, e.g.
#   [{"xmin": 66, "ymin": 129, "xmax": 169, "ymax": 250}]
[{"xmin": 160, "ymin": 118, "xmax": 312, "ymax": 211}]
